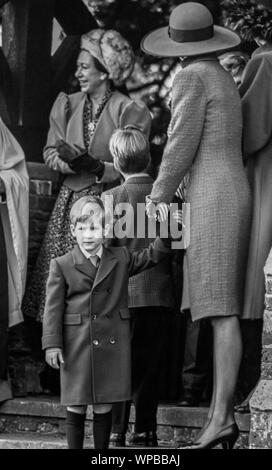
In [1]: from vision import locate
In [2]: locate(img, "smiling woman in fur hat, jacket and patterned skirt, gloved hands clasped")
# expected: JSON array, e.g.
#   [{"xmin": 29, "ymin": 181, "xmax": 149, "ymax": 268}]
[{"xmin": 24, "ymin": 29, "xmax": 151, "ymax": 318}]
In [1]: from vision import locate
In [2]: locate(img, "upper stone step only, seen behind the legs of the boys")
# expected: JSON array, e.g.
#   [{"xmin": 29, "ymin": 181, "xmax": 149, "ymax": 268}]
[{"xmin": 0, "ymin": 397, "xmax": 250, "ymax": 432}]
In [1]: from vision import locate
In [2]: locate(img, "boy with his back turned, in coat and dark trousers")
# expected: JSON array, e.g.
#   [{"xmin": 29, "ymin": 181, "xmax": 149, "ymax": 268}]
[{"xmin": 102, "ymin": 126, "xmax": 174, "ymax": 447}]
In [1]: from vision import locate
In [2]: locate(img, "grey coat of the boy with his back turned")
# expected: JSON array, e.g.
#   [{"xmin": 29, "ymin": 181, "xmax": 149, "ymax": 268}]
[{"xmin": 102, "ymin": 174, "xmax": 174, "ymax": 308}]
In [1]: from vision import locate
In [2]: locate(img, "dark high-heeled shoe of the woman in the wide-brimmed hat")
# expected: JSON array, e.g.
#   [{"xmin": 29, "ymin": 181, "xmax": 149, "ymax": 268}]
[{"xmin": 184, "ymin": 423, "xmax": 239, "ymax": 449}]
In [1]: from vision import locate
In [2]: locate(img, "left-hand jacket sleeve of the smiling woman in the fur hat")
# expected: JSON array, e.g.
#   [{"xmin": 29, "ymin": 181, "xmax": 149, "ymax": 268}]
[{"xmin": 43, "ymin": 93, "xmax": 74, "ymax": 174}]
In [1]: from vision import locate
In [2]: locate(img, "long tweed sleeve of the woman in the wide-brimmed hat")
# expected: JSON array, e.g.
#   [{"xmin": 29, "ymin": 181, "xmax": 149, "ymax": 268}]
[{"xmin": 151, "ymin": 69, "xmax": 207, "ymax": 204}]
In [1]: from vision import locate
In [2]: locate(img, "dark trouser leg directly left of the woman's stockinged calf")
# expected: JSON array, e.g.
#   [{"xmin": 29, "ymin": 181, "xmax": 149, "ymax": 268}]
[{"xmin": 182, "ymin": 310, "xmax": 213, "ymax": 400}]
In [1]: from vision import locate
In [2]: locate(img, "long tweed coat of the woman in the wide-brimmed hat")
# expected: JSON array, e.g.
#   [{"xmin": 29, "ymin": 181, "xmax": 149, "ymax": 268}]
[{"xmin": 151, "ymin": 57, "xmax": 251, "ymax": 320}]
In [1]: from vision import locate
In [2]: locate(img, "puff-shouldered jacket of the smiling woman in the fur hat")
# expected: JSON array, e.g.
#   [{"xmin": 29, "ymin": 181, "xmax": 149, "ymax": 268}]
[{"xmin": 44, "ymin": 90, "xmax": 151, "ymax": 191}]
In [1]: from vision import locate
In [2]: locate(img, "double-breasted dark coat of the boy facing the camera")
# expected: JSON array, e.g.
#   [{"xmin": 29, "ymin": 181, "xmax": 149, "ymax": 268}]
[{"xmin": 42, "ymin": 239, "xmax": 169, "ymax": 405}]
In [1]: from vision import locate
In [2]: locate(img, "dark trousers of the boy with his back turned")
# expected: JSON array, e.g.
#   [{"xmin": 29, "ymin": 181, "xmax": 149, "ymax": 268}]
[{"xmin": 112, "ymin": 307, "xmax": 169, "ymax": 433}]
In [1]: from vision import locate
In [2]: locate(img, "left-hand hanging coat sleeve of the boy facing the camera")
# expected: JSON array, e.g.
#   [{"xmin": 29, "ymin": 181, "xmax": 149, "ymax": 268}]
[{"xmin": 42, "ymin": 259, "xmax": 65, "ymax": 349}]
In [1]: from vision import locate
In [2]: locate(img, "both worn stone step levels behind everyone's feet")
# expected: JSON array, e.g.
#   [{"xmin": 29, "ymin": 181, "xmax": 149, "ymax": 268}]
[{"xmin": 0, "ymin": 396, "xmax": 250, "ymax": 448}]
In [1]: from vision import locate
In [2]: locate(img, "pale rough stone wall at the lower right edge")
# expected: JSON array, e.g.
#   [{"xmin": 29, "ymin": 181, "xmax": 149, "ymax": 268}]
[{"xmin": 249, "ymin": 249, "xmax": 272, "ymax": 449}]
